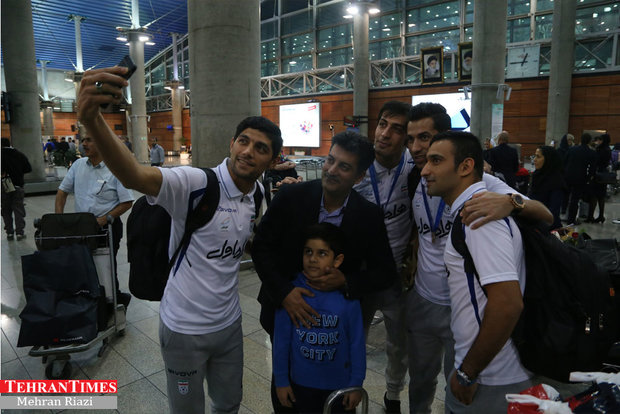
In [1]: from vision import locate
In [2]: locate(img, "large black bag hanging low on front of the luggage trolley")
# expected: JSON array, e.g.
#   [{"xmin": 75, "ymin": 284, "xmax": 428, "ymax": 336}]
[{"xmin": 17, "ymin": 244, "xmax": 100, "ymax": 346}]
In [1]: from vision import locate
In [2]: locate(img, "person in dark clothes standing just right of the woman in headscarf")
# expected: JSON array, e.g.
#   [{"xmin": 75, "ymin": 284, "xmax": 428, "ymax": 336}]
[{"xmin": 564, "ymin": 133, "xmax": 596, "ymax": 224}]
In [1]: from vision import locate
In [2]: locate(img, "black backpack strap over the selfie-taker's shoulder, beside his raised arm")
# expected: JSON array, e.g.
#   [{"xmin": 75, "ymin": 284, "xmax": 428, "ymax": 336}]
[{"xmin": 168, "ymin": 168, "xmax": 220, "ymax": 273}]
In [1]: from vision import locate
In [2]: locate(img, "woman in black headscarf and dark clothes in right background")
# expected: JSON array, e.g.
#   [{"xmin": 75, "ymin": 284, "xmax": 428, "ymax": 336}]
[{"xmin": 528, "ymin": 146, "xmax": 566, "ymax": 229}]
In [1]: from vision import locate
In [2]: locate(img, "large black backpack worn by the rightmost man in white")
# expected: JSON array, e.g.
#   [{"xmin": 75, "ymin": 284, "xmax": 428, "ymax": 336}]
[{"xmin": 450, "ymin": 213, "xmax": 620, "ymax": 382}]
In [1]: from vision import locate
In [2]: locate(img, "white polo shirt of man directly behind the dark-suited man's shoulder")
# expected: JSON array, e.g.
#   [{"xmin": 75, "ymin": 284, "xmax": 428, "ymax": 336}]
[{"xmin": 353, "ymin": 149, "xmax": 414, "ymax": 267}]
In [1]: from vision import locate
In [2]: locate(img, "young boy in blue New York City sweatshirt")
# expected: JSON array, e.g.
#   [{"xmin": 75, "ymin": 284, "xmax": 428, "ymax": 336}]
[{"xmin": 273, "ymin": 223, "xmax": 366, "ymax": 413}]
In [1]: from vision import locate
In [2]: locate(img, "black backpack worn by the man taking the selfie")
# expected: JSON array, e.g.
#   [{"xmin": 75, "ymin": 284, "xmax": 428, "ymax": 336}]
[{"xmin": 127, "ymin": 168, "xmax": 263, "ymax": 301}]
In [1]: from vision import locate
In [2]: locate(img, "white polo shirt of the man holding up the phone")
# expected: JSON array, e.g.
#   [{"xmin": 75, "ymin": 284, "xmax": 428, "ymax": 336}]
[{"xmin": 147, "ymin": 158, "xmax": 260, "ymax": 335}]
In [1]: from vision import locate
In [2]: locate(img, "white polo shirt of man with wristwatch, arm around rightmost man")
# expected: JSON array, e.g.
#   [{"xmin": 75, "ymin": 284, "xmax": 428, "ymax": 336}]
[{"xmin": 412, "ymin": 174, "xmax": 527, "ymax": 306}]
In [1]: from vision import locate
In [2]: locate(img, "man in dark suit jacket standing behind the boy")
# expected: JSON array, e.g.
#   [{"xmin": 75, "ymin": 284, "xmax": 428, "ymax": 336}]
[{"xmin": 252, "ymin": 132, "xmax": 398, "ymax": 413}]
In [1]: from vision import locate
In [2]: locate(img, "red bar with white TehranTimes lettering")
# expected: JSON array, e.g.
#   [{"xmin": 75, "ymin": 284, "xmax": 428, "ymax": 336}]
[{"xmin": 0, "ymin": 380, "xmax": 118, "ymax": 394}]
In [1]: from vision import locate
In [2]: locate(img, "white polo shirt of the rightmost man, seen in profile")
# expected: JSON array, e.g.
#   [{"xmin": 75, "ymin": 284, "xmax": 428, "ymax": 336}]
[{"xmin": 444, "ymin": 181, "xmax": 531, "ymax": 385}]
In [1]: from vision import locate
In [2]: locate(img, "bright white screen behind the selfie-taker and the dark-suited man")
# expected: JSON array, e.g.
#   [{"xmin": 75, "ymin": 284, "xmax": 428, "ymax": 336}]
[{"xmin": 280, "ymin": 102, "xmax": 321, "ymax": 148}]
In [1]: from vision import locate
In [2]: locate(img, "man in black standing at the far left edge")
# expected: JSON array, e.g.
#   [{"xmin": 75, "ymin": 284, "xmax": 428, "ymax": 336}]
[{"xmin": 2, "ymin": 138, "xmax": 32, "ymax": 240}]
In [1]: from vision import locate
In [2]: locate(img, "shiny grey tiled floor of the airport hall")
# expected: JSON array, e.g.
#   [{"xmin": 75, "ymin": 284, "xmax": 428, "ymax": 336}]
[{"xmin": 0, "ymin": 173, "xmax": 620, "ymax": 414}]
